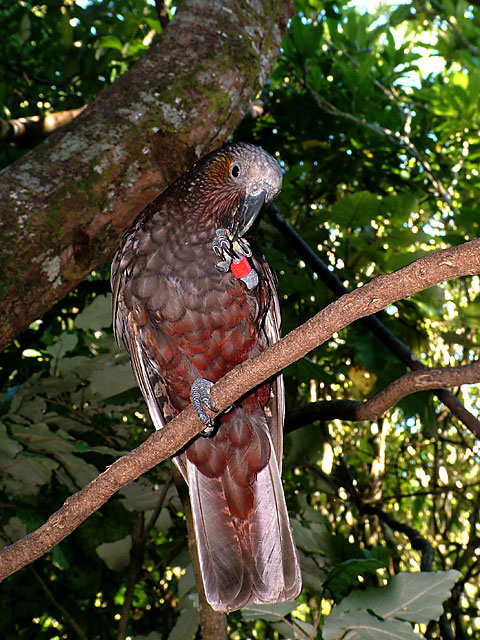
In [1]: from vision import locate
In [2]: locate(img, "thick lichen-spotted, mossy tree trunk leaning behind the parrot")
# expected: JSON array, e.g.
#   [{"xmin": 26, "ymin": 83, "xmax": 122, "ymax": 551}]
[{"xmin": 0, "ymin": 0, "xmax": 293, "ymax": 348}]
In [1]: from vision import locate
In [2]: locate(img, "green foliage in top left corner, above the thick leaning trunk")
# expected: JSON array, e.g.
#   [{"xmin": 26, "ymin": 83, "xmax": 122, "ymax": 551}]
[{"xmin": 0, "ymin": 0, "xmax": 161, "ymax": 166}]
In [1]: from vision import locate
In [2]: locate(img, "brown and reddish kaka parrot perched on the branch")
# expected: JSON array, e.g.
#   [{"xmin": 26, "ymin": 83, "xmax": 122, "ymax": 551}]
[{"xmin": 111, "ymin": 143, "xmax": 301, "ymax": 612}]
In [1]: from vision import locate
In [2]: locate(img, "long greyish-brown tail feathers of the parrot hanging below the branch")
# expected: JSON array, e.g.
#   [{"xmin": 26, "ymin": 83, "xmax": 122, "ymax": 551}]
[{"xmin": 186, "ymin": 438, "xmax": 301, "ymax": 613}]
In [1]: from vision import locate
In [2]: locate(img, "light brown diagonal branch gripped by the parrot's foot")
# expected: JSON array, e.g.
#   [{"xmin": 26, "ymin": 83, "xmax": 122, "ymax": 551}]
[{"xmin": 0, "ymin": 239, "xmax": 480, "ymax": 580}]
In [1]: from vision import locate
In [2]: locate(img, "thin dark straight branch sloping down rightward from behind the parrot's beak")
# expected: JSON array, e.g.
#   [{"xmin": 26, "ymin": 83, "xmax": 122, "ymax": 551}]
[{"xmin": 268, "ymin": 205, "xmax": 480, "ymax": 434}]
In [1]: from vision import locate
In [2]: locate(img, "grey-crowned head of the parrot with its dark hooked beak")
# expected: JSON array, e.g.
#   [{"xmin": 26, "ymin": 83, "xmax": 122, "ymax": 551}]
[{"xmin": 174, "ymin": 142, "xmax": 282, "ymax": 239}]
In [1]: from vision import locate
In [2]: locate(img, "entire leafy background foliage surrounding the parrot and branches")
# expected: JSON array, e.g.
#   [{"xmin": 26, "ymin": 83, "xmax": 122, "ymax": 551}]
[{"xmin": 0, "ymin": 0, "xmax": 480, "ymax": 640}]
